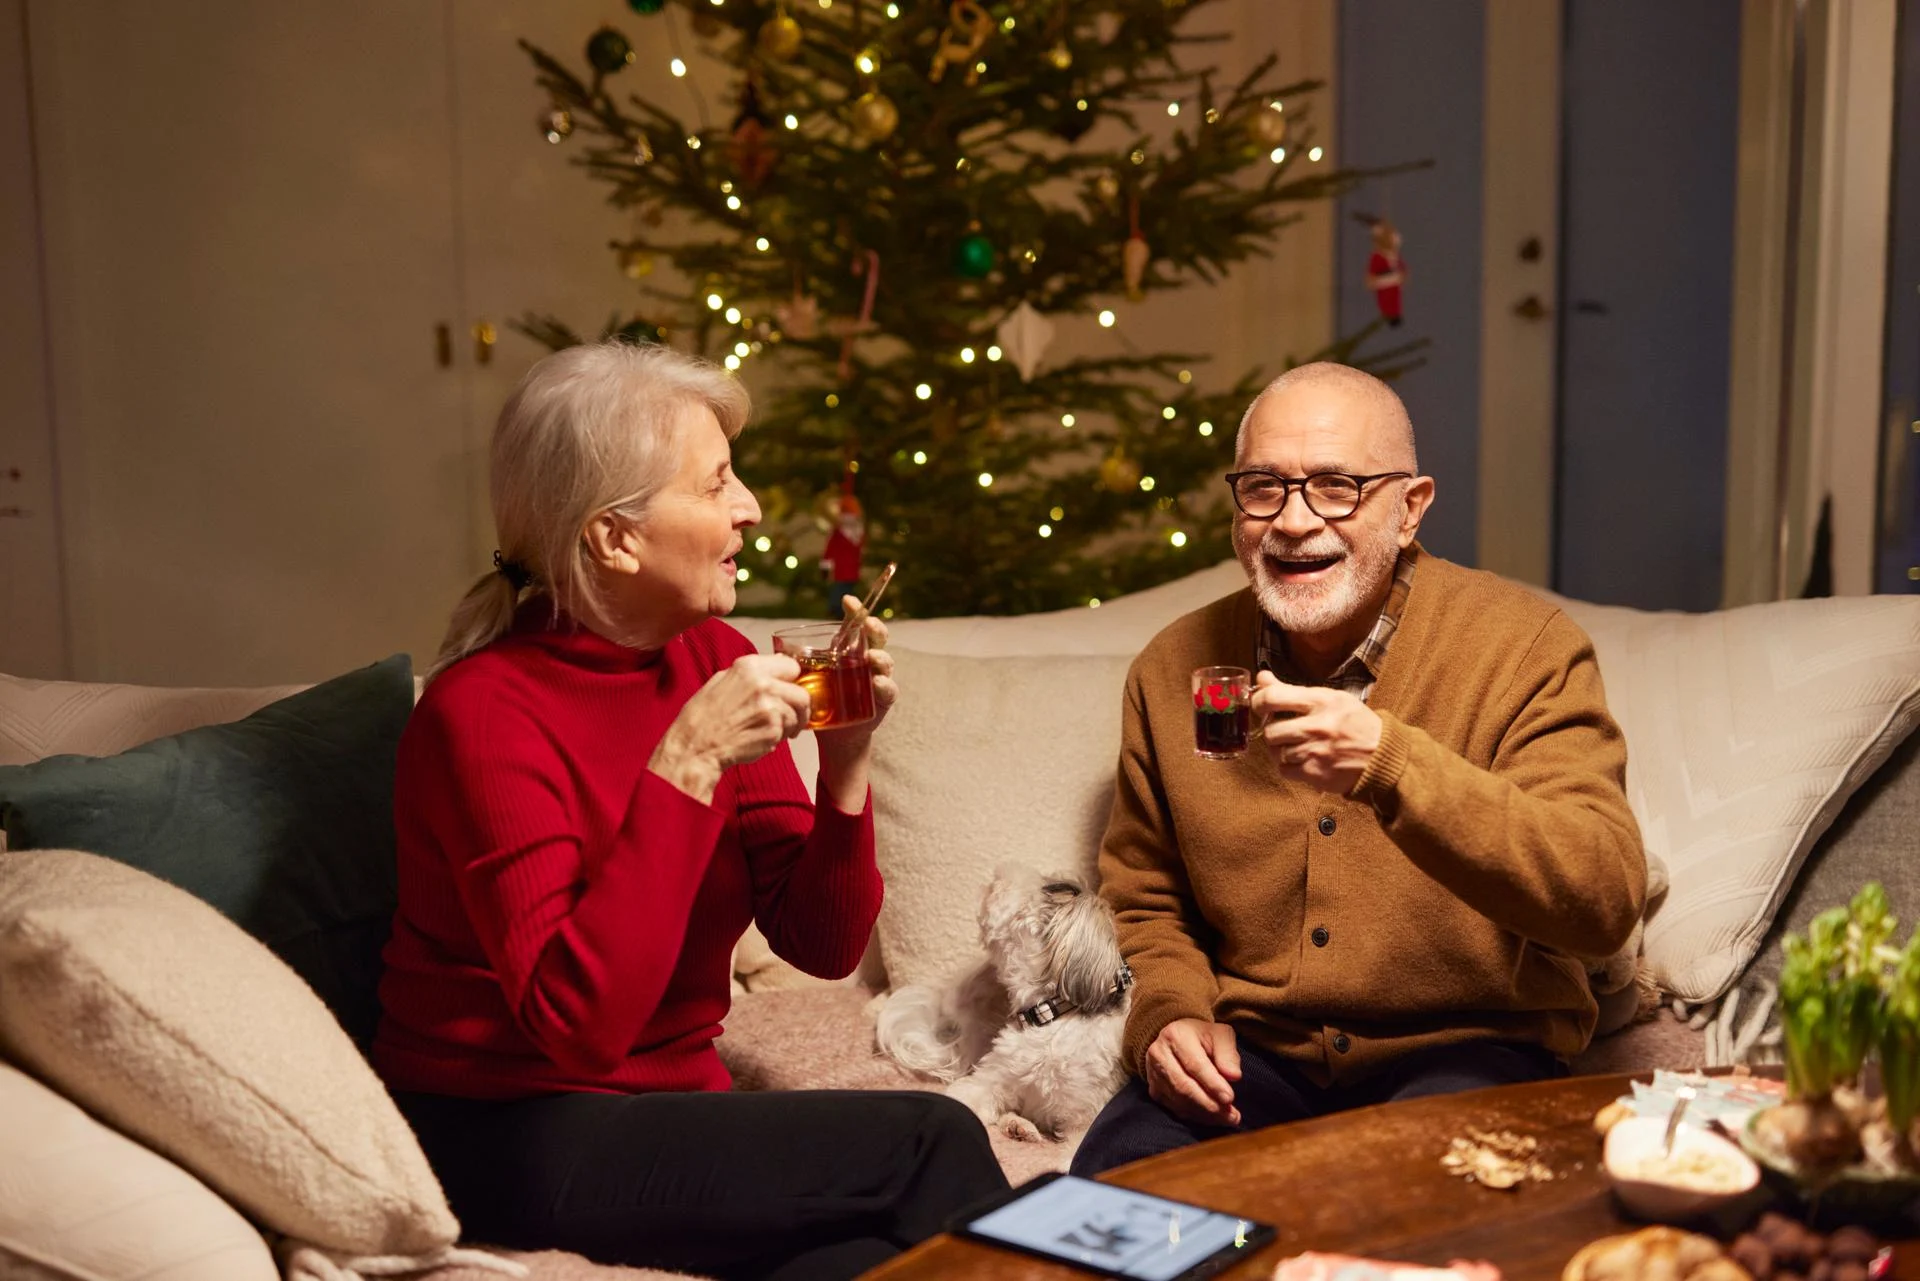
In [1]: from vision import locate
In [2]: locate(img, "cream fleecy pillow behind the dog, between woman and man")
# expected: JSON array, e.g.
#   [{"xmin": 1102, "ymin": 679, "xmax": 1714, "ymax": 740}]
[{"xmin": 874, "ymin": 649, "xmax": 1133, "ymax": 987}]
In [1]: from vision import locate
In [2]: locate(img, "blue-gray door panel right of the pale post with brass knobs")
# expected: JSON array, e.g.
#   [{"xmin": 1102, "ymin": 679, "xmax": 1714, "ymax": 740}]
[{"xmin": 1553, "ymin": 0, "xmax": 1741, "ymax": 609}]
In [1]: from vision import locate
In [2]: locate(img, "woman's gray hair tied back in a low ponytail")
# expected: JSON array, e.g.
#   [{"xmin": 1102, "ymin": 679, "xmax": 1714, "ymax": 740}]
[{"xmin": 426, "ymin": 342, "xmax": 751, "ymax": 680}]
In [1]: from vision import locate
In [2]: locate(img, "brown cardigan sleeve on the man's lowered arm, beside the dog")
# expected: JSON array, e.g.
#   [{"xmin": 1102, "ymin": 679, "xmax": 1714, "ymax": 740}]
[{"xmin": 1100, "ymin": 663, "xmax": 1219, "ymax": 1074}]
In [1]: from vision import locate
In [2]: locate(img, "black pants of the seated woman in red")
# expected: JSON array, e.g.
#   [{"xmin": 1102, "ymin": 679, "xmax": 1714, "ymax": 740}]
[{"xmin": 396, "ymin": 1091, "xmax": 1006, "ymax": 1281}]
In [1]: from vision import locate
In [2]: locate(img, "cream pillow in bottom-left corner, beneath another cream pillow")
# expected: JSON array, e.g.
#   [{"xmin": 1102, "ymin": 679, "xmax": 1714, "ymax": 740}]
[{"xmin": 0, "ymin": 1064, "xmax": 280, "ymax": 1281}]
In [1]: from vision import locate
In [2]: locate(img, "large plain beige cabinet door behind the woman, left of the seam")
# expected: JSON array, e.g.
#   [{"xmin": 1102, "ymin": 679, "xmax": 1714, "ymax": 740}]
[{"xmin": 27, "ymin": 0, "xmax": 474, "ymax": 684}]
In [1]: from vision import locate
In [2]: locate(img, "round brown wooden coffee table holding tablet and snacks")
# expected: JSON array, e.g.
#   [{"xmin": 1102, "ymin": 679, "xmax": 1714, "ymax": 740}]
[{"xmin": 868, "ymin": 1074, "xmax": 1920, "ymax": 1281}]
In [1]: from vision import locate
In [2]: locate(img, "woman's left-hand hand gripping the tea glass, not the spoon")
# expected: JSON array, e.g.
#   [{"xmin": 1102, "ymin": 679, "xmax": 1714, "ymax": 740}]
[{"xmin": 647, "ymin": 653, "xmax": 810, "ymax": 805}]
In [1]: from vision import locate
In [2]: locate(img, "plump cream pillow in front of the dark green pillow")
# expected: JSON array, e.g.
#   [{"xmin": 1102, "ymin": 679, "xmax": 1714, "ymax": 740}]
[{"xmin": 0, "ymin": 851, "xmax": 459, "ymax": 1254}]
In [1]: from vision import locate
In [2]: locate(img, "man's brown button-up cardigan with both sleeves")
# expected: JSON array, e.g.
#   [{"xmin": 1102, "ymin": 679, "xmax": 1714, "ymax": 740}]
[{"xmin": 1100, "ymin": 555, "xmax": 1647, "ymax": 1083}]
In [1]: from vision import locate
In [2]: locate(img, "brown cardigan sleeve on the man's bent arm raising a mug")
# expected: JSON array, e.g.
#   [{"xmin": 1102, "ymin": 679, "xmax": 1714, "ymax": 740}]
[{"xmin": 1352, "ymin": 613, "xmax": 1647, "ymax": 958}]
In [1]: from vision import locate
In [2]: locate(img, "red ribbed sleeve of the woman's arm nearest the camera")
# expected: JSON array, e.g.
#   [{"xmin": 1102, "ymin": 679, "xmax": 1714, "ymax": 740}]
[{"xmin": 399, "ymin": 691, "xmax": 724, "ymax": 1076}]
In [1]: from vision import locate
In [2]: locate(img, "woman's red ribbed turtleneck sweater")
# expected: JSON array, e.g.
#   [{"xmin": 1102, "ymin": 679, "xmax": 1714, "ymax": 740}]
[{"xmin": 372, "ymin": 607, "xmax": 881, "ymax": 1099}]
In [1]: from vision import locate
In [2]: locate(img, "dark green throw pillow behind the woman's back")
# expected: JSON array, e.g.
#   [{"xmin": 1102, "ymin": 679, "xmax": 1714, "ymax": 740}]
[{"xmin": 0, "ymin": 655, "xmax": 413, "ymax": 1047}]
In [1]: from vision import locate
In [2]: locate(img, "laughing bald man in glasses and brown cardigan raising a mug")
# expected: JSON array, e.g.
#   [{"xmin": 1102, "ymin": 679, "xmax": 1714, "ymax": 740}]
[{"xmin": 1073, "ymin": 355, "xmax": 1645, "ymax": 1173}]
